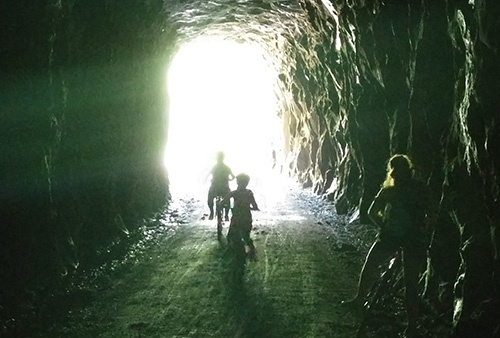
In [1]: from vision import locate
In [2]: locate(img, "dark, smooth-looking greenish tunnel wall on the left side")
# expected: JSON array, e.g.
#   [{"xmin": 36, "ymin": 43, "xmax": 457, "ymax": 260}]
[{"xmin": 0, "ymin": 1, "xmax": 173, "ymax": 324}]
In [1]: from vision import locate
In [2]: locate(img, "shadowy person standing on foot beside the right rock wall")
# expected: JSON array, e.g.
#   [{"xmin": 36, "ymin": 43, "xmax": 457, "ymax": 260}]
[{"xmin": 343, "ymin": 154, "xmax": 436, "ymax": 337}]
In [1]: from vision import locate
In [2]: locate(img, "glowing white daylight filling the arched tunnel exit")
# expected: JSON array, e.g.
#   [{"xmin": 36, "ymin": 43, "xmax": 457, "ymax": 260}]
[{"xmin": 165, "ymin": 37, "xmax": 283, "ymax": 204}]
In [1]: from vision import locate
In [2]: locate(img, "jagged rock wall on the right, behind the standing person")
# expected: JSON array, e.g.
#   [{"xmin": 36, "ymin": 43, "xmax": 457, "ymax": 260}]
[{"xmin": 291, "ymin": 1, "xmax": 500, "ymax": 335}]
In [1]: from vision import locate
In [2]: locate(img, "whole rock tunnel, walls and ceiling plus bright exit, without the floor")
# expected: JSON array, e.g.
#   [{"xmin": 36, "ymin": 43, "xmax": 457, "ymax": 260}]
[{"xmin": 0, "ymin": 0, "xmax": 500, "ymax": 337}]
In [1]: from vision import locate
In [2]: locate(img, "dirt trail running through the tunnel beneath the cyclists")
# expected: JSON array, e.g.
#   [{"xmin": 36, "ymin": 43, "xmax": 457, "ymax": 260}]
[{"xmin": 44, "ymin": 189, "xmax": 372, "ymax": 338}]
